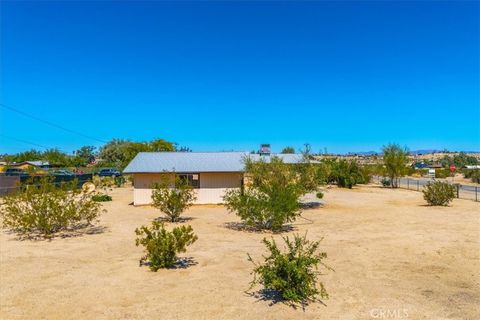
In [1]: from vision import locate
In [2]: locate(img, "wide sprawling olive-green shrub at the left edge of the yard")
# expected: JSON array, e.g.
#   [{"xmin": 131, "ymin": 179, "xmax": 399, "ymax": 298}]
[{"xmin": 0, "ymin": 177, "xmax": 101, "ymax": 237}]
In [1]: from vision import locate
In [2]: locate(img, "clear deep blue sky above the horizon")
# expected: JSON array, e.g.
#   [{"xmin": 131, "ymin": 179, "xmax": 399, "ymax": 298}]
[{"xmin": 0, "ymin": 1, "xmax": 480, "ymax": 153}]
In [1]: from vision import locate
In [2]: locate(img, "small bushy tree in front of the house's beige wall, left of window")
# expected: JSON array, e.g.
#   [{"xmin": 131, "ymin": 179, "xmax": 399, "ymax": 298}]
[{"xmin": 152, "ymin": 178, "xmax": 196, "ymax": 222}]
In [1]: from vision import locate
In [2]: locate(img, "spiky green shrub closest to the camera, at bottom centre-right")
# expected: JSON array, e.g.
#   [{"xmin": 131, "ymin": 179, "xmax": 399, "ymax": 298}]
[{"xmin": 248, "ymin": 235, "xmax": 331, "ymax": 304}]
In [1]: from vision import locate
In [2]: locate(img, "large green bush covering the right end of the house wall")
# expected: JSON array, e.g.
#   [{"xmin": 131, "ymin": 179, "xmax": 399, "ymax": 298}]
[{"xmin": 223, "ymin": 157, "xmax": 314, "ymax": 230}]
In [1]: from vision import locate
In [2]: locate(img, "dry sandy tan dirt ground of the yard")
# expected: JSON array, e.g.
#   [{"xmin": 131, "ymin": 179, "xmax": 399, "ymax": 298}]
[{"xmin": 0, "ymin": 186, "xmax": 480, "ymax": 319}]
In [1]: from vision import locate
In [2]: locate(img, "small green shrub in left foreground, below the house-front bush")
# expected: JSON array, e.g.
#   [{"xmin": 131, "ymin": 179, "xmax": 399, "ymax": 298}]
[{"xmin": 135, "ymin": 221, "xmax": 198, "ymax": 271}]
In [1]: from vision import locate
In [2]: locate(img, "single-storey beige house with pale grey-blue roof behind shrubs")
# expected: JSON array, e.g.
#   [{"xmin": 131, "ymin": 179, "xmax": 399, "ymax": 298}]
[{"xmin": 123, "ymin": 152, "xmax": 303, "ymax": 205}]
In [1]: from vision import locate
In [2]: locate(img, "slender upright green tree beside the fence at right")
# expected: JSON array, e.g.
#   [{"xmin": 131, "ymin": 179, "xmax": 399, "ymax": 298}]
[{"xmin": 383, "ymin": 144, "xmax": 408, "ymax": 188}]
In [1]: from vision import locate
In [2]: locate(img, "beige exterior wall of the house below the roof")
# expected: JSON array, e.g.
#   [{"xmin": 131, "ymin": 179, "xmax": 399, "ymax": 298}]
[{"xmin": 133, "ymin": 172, "xmax": 242, "ymax": 205}]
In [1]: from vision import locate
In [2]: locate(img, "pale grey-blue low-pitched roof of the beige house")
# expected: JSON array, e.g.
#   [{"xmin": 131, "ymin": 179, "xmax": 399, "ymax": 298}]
[{"xmin": 123, "ymin": 152, "xmax": 302, "ymax": 173}]
